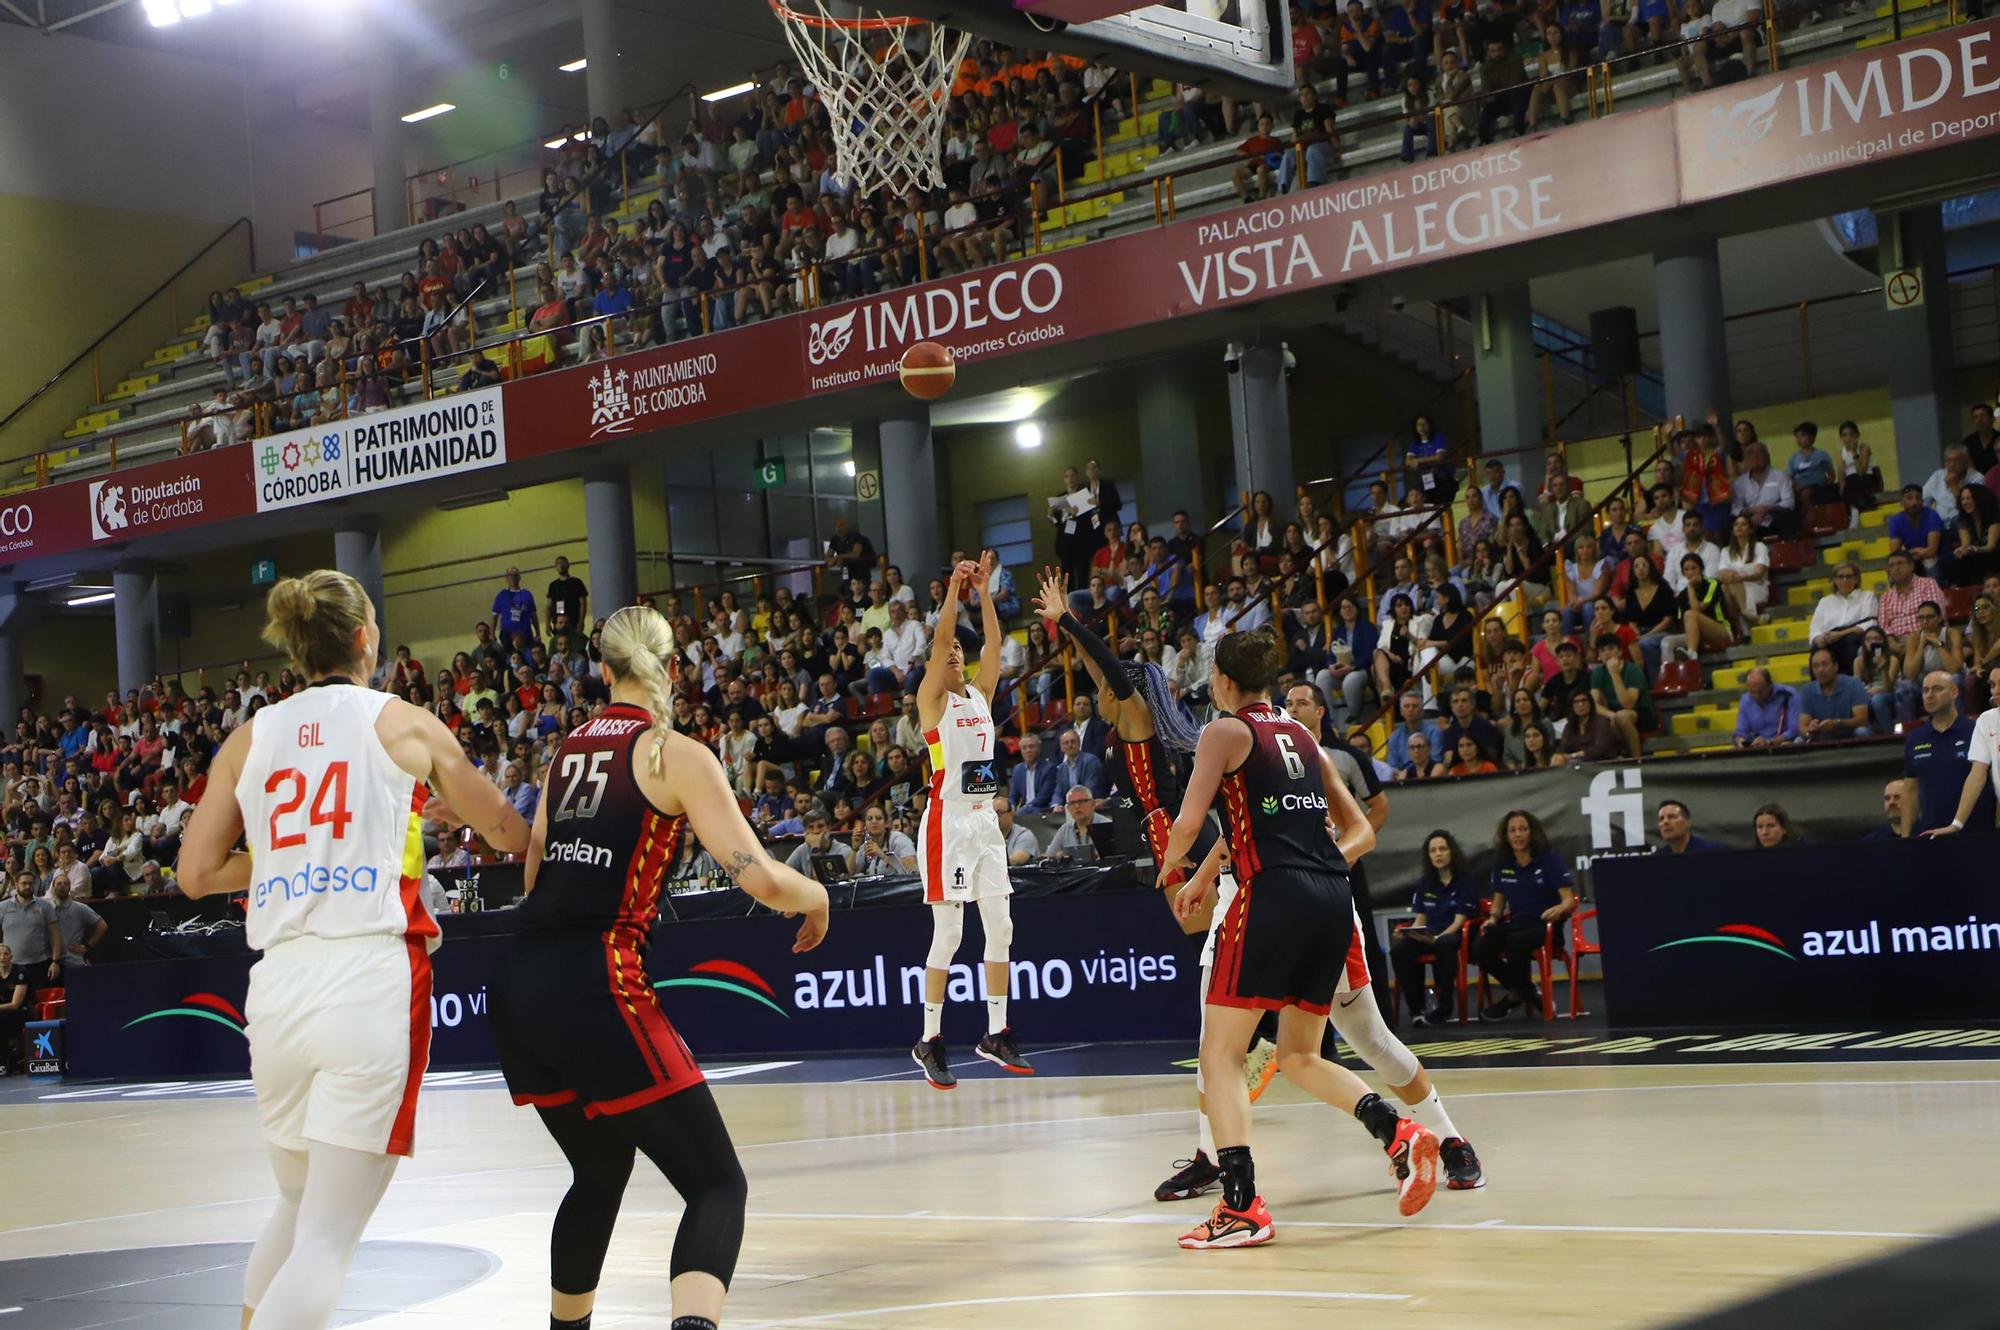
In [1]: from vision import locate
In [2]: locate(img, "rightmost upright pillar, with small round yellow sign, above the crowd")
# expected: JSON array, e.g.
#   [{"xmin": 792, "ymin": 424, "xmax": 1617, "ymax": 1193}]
[{"xmin": 1878, "ymin": 204, "xmax": 1960, "ymax": 484}]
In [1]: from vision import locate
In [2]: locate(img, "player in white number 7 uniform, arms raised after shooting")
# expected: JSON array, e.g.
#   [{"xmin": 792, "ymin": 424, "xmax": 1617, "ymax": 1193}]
[{"xmin": 910, "ymin": 550, "xmax": 1034, "ymax": 1090}]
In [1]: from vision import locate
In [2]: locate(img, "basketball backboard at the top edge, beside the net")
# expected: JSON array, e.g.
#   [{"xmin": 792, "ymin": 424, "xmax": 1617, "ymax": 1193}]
[{"xmin": 880, "ymin": 0, "xmax": 1292, "ymax": 96}]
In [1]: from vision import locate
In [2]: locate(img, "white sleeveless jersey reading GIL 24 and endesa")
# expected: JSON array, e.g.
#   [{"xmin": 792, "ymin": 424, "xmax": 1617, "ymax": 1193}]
[{"xmin": 236, "ymin": 684, "xmax": 438, "ymax": 952}]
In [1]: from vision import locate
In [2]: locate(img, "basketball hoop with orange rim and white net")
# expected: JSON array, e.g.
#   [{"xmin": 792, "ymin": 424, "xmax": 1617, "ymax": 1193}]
[{"xmin": 770, "ymin": 0, "xmax": 972, "ymax": 194}]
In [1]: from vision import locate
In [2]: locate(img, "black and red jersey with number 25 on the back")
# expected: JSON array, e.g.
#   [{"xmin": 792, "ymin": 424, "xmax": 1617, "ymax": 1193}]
[{"xmin": 514, "ymin": 702, "xmax": 686, "ymax": 952}]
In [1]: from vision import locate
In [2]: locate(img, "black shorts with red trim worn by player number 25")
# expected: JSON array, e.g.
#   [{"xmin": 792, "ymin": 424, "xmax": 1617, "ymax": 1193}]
[{"xmin": 488, "ymin": 936, "xmax": 702, "ymax": 1118}]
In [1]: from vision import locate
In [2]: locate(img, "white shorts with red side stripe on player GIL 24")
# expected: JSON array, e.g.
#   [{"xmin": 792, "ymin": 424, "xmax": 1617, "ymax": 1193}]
[{"xmin": 244, "ymin": 934, "xmax": 430, "ymax": 1154}]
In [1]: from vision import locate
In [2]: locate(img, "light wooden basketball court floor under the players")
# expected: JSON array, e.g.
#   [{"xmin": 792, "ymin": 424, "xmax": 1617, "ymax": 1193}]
[{"xmin": 0, "ymin": 1062, "xmax": 2000, "ymax": 1330}]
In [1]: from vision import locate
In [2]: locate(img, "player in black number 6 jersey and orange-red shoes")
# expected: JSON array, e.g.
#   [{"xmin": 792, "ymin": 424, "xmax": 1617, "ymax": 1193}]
[{"xmin": 1166, "ymin": 632, "xmax": 1438, "ymax": 1248}]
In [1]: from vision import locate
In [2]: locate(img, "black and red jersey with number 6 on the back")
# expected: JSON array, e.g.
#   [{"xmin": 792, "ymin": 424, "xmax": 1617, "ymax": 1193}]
[{"xmin": 1216, "ymin": 702, "xmax": 1346, "ymax": 886}]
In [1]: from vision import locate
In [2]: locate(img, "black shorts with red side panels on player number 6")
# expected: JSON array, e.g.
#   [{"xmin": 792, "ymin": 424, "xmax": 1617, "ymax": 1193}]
[{"xmin": 1208, "ymin": 868, "xmax": 1368, "ymax": 1016}]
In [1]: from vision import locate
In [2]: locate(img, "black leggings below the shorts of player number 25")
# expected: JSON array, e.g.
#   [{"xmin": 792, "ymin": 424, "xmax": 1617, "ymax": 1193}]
[{"xmin": 536, "ymin": 1086, "xmax": 750, "ymax": 1294}]
